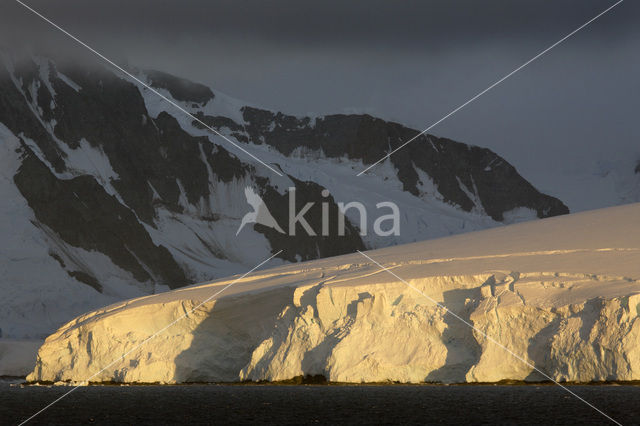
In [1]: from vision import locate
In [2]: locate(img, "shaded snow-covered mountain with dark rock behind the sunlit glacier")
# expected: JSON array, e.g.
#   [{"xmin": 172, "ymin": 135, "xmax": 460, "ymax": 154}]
[{"xmin": 0, "ymin": 53, "xmax": 568, "ymax": 343}]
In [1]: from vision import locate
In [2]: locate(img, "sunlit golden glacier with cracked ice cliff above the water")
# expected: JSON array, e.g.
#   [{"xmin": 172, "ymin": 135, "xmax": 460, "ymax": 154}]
[{"xmin": 28, "ymin": 204, "xmax": 640, "ymax": 383}]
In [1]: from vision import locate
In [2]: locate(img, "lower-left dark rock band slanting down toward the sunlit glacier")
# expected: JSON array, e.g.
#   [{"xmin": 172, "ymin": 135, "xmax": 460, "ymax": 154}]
[{"xmin": 14, "ymin": 146, "xmax": 188, "ymax": 288}]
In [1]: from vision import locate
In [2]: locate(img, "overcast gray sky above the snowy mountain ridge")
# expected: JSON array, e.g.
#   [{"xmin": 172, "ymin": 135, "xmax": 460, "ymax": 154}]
[{"xmin": 0, "ymin": 0, "xmax": 640, "ymax": 199}]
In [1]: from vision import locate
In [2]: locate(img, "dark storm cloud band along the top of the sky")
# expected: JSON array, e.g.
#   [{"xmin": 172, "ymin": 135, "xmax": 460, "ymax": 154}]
[{"xmin": 4, "ymin": 0, "xmax": 638, "ymax": 49}]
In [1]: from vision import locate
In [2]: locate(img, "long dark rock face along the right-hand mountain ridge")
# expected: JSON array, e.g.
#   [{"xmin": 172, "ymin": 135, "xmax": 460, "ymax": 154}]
[{"xmin": 239, "ymin": 107, "xmax": 569, "ymax": 221}]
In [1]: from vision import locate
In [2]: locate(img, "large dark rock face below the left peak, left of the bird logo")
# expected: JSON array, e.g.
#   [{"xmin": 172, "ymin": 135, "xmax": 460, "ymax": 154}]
[{"xmin": 48, "ymin": 65, "xmax": 228, "ymax": 224}]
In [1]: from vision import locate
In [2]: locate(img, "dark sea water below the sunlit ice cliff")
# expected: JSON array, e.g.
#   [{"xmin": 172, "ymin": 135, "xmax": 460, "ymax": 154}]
[{"xmin": 0, "ymin": 383, "xmax": 640, "ymax": 425}]
